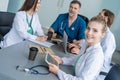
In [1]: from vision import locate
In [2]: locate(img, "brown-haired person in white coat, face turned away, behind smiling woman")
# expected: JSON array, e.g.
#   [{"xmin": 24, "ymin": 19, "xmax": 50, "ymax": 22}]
[{"xmin": 97, "ymin": 9, "xmax": 116, "ymax": 80}]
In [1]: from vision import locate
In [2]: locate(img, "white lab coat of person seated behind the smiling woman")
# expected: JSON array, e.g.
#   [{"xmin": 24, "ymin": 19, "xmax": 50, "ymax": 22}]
[{"xmin": 97, "ymin": 28, "xmax": 116, "ymax": 80}]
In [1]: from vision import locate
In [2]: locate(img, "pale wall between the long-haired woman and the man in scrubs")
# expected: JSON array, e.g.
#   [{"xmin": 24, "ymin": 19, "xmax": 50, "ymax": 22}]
[{"xmin": 39, "ymin": 0, "xmax": 71, "ymax": 27}]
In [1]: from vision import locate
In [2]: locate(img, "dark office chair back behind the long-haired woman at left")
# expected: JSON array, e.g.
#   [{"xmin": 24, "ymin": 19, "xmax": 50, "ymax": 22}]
[{"xmin": 0, "ymin": 11, "xmax": 15, "ymax": 42}]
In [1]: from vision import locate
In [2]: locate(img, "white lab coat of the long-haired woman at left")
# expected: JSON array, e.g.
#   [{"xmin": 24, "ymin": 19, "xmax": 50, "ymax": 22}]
[{"xmin": 1, "ymin": 11, "xmax": 44, "ymax": 48}]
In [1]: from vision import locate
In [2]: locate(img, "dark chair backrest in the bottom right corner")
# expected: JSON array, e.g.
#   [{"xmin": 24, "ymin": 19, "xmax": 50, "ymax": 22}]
[{"xmin": 105, "ymin": 65, "xmax": 120, "ymax": 80}]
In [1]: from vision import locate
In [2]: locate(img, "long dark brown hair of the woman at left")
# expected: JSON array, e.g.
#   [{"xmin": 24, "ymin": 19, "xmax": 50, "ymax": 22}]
[{"xmin": 19, "ymin": 0, "xmax": 38, "ymax": 11}]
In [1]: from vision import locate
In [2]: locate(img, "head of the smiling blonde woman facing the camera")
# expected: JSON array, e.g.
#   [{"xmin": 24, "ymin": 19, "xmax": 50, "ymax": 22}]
[{"xmin": 85, "ymin": 17, "xmax": 107, "ymax": 46}]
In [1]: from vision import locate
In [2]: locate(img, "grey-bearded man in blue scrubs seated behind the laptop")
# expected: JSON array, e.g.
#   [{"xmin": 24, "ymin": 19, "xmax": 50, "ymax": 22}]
[{"xmin": 49, "ymin": 1, "xmax": 86, "ymax": 44}]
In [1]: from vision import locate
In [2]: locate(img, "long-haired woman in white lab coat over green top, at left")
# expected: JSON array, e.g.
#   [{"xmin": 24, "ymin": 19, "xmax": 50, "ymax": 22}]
[{"xmin": 1, "ymin": 0, "xmax": 47, "ymax": 48}]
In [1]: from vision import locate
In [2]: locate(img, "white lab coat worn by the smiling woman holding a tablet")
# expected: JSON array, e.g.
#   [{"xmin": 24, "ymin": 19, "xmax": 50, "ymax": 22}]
[{"xmin": 58, "ymin": 43, "xmax": 104, "ymax": 80}]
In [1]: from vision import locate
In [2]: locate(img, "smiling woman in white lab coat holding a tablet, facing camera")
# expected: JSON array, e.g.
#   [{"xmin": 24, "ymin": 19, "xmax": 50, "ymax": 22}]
[{"xmin": 49, "ymin": 17, "xmax": 106, "ymax": 80}]
